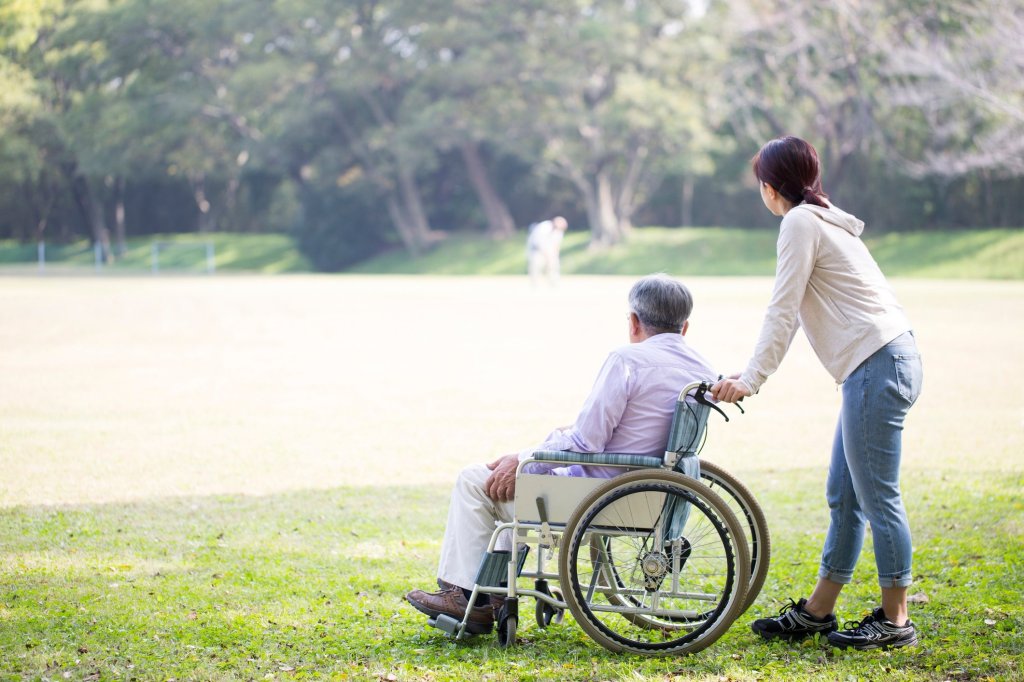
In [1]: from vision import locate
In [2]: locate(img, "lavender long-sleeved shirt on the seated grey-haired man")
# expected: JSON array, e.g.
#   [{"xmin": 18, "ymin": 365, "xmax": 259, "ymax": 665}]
[{"xmin": 520, "ymin": 334, "xmax": 718, "ymax": 478}]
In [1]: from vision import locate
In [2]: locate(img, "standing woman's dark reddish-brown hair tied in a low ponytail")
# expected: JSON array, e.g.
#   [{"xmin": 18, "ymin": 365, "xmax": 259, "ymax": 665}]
[{"xmin": 751, "ymin": 135, "xmax": 828, "ymax": 208}]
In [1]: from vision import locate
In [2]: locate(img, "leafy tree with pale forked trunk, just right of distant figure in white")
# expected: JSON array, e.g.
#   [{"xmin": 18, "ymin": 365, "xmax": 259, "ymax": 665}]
[{"xmin": 475, "ymin": 1, "xmax": 716, "ymax": 246}]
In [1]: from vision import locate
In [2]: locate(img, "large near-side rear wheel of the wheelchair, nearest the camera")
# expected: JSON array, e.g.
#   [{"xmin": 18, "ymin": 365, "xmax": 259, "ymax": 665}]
[{"xmin": 559, "ymin": 470, "xmax": 750, "ymax": 655}]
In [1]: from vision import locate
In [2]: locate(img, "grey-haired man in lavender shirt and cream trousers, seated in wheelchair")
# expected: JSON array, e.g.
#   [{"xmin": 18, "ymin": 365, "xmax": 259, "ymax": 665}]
[{"xmin": 406, "ymin": 274, "xmax": 717, "ymax": 634}]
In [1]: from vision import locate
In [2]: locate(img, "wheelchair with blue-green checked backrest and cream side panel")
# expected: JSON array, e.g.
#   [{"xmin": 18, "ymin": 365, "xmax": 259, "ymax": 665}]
[{"xmin": 428, "ymin": 381, "xmax": 771, "ymax": 655}]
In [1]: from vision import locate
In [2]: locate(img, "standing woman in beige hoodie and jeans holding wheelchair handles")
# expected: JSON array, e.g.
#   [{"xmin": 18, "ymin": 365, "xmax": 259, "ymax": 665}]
[{"xmin": 712, "ymin": 137, "xmax": 922, "ymax": 649}]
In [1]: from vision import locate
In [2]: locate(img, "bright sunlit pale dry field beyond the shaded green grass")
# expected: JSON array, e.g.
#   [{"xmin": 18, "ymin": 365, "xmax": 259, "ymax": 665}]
[{"xmin": 0, "ymin": 275, "xmax": 1024, "ymax": 507}]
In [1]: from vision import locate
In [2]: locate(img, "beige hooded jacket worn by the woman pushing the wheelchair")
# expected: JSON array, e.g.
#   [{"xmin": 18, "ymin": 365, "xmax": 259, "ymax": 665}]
[{"xmin": 740, "ymin": 203, "xmax": 910, "ymax": 392}]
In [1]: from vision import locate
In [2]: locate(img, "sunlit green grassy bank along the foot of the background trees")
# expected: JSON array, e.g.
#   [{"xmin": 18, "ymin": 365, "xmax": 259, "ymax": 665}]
[{"xmin": 0, "ymin": 227, "xmax": 1024, "ymax": 280}]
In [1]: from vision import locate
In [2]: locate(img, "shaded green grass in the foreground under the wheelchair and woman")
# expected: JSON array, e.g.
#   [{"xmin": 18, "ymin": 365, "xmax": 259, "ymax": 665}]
[{"xmin": 0, "ymin": 470, "xmax": 1024, "ymax": 680}]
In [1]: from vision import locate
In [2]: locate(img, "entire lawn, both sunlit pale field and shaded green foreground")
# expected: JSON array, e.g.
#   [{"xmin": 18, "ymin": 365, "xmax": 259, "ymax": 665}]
[{"xmin": 0, "ymin": 275, "xmax": 1024, "ymax": 679}]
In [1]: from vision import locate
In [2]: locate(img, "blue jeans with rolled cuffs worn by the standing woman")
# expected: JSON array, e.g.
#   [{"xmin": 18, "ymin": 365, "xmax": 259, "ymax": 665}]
[{"xmin": 818, "ymin": 332, "xmax": 923, "ymax": 588}]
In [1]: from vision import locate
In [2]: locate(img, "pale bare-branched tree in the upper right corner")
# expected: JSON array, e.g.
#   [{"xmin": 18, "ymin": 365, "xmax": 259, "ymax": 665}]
[{"xmin": 883, "ymin": 0, "xmax": 1024, "ymax": 178}]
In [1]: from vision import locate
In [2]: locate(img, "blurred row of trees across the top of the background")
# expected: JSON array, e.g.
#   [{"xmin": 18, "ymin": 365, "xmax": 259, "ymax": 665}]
[{"xmin": 0, "ymin": 0, "xmax": 1024, "ymax": 270}]
